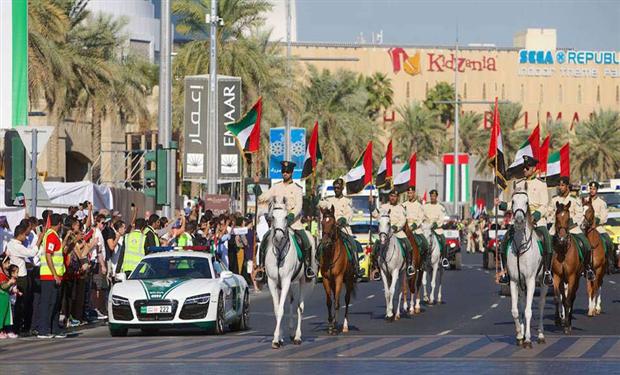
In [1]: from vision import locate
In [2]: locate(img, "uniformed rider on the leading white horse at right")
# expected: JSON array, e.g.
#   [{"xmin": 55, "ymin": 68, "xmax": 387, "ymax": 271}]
[{"xmin": 499, "ymin": 155, "xmax": 555, "ymax": 286}]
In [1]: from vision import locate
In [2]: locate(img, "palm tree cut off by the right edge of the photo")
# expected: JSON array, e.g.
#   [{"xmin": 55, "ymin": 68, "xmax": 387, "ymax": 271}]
[{"xmin": 571, "ymin": 110, "xmax": 620, "ymax": 181}]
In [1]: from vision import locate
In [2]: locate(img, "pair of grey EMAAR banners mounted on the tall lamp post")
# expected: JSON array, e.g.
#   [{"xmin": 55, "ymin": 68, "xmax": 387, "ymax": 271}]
[{"xmin": 183, "ymin": 75, "xmax": 242, "ymax": 182}]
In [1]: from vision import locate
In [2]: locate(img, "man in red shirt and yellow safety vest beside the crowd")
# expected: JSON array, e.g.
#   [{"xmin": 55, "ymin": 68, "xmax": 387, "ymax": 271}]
[{"xmin": 37, "ymin": 214, "xmax": 67, "ymax": 339}]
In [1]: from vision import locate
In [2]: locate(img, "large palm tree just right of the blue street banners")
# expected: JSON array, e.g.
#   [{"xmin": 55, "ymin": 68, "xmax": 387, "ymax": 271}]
[{"xmin": 301, "ymin": 65, "xmax": 383, "ymax": 178}]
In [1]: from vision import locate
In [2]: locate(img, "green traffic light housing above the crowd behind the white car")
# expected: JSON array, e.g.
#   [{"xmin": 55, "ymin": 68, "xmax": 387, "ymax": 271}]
[{"xmin": 144, "ymin": 145, "xmax": 169, "ymax": 205}]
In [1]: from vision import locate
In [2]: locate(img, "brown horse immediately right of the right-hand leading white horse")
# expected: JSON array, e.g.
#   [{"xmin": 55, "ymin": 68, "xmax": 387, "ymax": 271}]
[{"xmin": 551, "ymin": 202, "xmax": 583, "ymax": 334}]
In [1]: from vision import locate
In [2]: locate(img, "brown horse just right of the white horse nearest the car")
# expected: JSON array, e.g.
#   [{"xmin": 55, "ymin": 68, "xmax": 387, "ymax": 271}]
[{"xmin": 319, "ymin": 206, "xmax": 357, "ymax": 335}]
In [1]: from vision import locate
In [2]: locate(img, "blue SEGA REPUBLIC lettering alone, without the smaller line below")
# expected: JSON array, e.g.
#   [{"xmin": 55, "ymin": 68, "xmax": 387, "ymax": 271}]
[{"xmin": 519, "ymin": 49, "xmax": 620, "ymax": 65}]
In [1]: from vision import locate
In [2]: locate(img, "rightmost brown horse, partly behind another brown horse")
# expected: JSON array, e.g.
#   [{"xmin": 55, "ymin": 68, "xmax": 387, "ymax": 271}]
[{"xmin": 582, "ymin": 198, "xmax": 607, "ymax": 316}]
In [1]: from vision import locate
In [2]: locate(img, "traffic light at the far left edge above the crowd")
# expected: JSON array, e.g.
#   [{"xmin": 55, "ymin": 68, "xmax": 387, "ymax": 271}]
[{"xmin": 3, "ymin": 130, "xmax": 26, "ymax": 206}]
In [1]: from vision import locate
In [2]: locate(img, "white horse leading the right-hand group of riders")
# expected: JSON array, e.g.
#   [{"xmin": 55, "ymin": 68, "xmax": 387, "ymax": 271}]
[{"xmin": 506, "ymin": 186, "xmax": 547, "ymax": 349}]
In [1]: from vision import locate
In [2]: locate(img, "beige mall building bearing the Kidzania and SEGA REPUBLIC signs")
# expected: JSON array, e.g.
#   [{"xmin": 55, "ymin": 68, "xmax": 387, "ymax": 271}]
[{"xmin": 292, "ymin": 29, "xmax": 620, "ymax": 129}]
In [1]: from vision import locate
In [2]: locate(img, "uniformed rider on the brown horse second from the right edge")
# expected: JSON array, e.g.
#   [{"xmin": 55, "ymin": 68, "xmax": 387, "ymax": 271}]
[{"xmin": 549, "ymin": 176, "xmax": 594, "ymax": 280}]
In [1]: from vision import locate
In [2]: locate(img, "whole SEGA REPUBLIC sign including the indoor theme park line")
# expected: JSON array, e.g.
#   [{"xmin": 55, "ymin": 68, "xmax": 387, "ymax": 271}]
[{"xmin": 518, "ymin": 49, "xmax": 620, "ymax": 78}]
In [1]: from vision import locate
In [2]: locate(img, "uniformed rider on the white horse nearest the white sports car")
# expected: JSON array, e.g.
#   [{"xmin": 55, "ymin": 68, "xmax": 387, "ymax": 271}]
[{"xmin": 254, "ymin": 161, "xmax": 316, "ymax": 280}]
